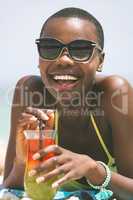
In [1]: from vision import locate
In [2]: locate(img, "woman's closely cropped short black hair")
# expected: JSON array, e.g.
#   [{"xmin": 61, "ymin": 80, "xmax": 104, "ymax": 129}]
[{"xmin": 40, "ymin": 7, "xmax": 104, "ymax": 49}]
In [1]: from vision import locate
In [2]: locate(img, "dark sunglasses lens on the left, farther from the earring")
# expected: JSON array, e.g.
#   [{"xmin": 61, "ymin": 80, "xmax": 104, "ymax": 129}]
[{"xmin": 38, "ymin": 38, "xmax": 61, "ymax": 60}]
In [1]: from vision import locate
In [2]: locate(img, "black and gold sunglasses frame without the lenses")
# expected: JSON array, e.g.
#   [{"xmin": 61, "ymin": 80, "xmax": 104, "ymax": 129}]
[{"xmin": 35, "ymin": 37, "xmax": 103, "ymax": 63}]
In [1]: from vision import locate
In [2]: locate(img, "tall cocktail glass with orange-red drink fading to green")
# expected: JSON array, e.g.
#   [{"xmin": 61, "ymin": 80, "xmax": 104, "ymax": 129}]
[{"xmin": 24, "ymin": 111, "xmax": 57, "ymax": 200}]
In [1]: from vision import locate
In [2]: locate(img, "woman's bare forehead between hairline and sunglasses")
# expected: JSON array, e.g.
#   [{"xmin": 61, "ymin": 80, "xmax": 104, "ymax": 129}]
[{"xmin": 42, "ymin": 17, "xmax": 97, "ymax": 42}]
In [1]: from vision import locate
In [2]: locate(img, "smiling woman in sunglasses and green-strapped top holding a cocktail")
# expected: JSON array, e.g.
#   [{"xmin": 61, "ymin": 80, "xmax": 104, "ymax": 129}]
[{"xmin": 1, "ymin": 8, "xmax": 133, "ymax": 200}]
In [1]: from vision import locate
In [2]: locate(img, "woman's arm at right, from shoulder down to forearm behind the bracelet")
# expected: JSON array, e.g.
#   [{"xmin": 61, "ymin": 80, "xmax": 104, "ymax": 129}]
[{"xmin": 103, "ymin": 76, "xmax": 133, "ymax": 200}]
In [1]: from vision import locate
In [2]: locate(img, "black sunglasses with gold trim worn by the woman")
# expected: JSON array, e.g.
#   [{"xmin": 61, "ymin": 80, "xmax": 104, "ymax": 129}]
[{"xmin": 36, "ymin": 38, "xmax": 102, "ymax": 62}]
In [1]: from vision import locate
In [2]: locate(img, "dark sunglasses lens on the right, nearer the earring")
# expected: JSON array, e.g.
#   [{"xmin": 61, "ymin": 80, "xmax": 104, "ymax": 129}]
[{"xmin": 69, "ymin": 40, "xmax": 94, "ymax": 61}]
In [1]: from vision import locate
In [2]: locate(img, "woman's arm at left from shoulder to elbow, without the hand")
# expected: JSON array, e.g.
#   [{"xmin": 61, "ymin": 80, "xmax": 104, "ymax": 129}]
[{"xmin": 3, "ymin": 76, "xmax": 42, "ymax": 187}]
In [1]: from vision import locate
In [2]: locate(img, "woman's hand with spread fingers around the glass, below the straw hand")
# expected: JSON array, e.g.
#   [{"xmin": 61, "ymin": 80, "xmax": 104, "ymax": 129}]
[{"xmin": 29, "ymin": 145, "xmax": 106, "ymax": 188}]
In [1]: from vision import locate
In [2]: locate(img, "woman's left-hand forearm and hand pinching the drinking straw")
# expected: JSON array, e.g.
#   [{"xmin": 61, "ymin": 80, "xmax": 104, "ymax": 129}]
[{"xmin": 15, "ymin": 107, "xmax": 53, "ymax": 163}]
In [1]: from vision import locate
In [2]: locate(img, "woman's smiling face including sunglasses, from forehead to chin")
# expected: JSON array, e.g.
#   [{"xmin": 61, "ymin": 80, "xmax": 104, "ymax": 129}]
[{"xmin": 37, "ymin": 16, "xmax": 104, "ymax": 106}]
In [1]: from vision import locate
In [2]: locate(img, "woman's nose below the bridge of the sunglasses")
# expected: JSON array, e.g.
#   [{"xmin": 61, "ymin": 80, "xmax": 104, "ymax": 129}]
[{"xmin": 56, "ymin": 48, "xmax": 74, "ymax": 66}]
